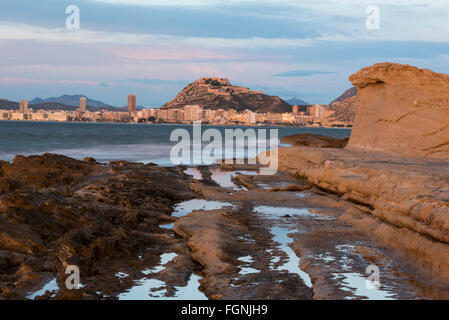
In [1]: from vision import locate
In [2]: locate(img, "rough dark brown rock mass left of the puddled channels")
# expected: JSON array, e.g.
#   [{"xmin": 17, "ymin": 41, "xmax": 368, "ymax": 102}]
[{"xmin": 0, "ymin": 154, "xmax": 195, "ymax": 299}]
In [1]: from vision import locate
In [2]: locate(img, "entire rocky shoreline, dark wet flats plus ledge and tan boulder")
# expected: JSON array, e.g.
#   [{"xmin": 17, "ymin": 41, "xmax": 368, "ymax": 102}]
[{"xmin": 0, "ymin": 64, "xmax": 449, "ymax": 300}]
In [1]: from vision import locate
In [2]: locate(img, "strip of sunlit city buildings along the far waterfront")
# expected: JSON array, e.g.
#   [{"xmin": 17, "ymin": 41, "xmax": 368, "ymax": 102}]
[{"xmin": 0, "ymin": 94, "xmax": 352, "ymax": 127}]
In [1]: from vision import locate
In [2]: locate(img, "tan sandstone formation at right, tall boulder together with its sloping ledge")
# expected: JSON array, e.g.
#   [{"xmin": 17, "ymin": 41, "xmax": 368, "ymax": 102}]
[{"xmin": 279, "ymin": 63, "xmax": 449, "ymax": 281}]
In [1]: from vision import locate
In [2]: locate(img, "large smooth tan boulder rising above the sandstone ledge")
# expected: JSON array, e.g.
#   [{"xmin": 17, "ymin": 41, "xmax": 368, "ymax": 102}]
[{"xmin": 348, "ymin": 63, "xmax": 449, "ymax": 159}]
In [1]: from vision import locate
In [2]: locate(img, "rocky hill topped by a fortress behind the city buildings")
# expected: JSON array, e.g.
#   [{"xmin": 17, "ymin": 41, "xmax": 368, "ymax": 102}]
[{"xmin": 161, "ymin": 78, "xmax": 291, "ymax": 112}]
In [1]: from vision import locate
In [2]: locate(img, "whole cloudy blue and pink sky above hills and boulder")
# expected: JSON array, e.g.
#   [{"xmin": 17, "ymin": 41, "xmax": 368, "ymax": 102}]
[{"xmin": 0, "ymin": 0, "xmax": 449, "ymax": 107}]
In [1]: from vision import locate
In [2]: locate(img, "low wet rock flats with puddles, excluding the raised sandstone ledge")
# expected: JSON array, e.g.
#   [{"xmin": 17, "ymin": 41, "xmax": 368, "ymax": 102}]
[{"xmin": 0, "ymin": 149, "xmax": 448, "ymax": 300}]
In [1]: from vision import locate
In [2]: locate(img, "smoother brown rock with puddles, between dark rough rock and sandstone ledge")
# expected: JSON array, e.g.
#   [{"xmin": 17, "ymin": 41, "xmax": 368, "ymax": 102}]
[{"xmin": 174, "ymin": 165, "xmax": 448, "ymax": 299}]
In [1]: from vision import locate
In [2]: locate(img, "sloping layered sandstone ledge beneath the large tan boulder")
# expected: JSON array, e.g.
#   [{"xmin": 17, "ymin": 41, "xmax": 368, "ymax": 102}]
[{"xmin": 279, "ymin": 147, "xmax": 449, "ymax": 280}]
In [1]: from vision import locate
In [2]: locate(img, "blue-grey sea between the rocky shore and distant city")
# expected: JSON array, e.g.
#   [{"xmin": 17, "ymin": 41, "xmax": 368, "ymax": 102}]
[{"xmin": 0, "ymin": 121, "xmax": 351, "ymax": 165}]
